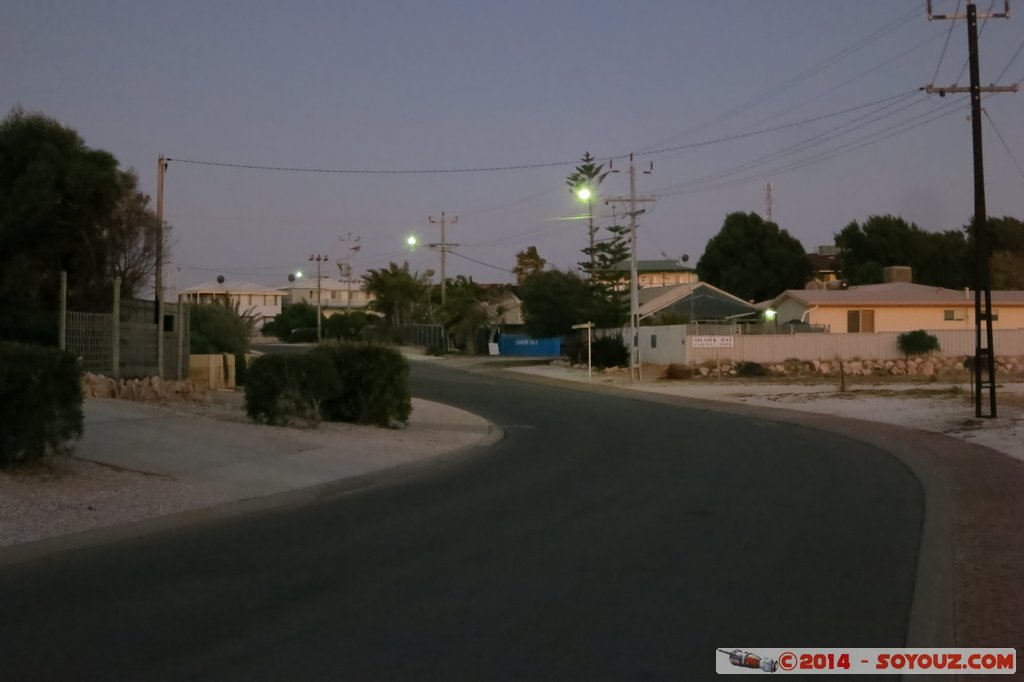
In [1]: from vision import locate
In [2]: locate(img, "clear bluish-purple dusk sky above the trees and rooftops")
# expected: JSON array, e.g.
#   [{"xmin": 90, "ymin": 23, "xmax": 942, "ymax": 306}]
[{"xmin": 0, "ymin": 0, "xmax": 1024, "ymax": 291}]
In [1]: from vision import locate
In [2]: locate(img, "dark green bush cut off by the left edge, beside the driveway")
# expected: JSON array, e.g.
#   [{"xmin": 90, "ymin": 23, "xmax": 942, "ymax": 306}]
[{"xmin": 0, "ymin": 342, "xmax": 84, "ymax": 466}]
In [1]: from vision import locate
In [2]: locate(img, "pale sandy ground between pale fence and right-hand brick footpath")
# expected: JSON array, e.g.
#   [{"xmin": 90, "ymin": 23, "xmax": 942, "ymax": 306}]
[{"xmin": 509, "ymin": 365, "xmax": 1024, "ymax": 461}]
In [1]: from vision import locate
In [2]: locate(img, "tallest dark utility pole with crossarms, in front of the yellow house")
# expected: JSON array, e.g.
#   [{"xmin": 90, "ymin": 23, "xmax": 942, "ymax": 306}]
[{"xmin": 925, "ymin": 0, "xmax": 1018, "ymax": 419}]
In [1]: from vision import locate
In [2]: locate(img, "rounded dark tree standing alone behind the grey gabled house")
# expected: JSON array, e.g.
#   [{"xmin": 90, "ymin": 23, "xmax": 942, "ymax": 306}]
[{"xmin": 696, "ymin": 213, "xmax": 813, "ymax": 301}]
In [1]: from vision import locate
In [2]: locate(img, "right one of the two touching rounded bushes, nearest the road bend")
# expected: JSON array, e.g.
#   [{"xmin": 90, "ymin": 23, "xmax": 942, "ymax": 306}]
[{"xmin": 311, "ymin": 343, "xmax": 413, "ymax": 426}]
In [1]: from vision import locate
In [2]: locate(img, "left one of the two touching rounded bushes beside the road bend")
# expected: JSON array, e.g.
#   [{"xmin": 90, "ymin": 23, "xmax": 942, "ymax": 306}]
[{"xmin": 246, "ymin": 353, "xmax": 338, "ymax": 424}]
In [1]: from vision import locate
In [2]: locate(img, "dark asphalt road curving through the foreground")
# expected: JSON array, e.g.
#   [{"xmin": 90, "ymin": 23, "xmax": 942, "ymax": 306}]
[{"xmin": 0, "ymin": 363, "xmax": 923, "ymax": 681}]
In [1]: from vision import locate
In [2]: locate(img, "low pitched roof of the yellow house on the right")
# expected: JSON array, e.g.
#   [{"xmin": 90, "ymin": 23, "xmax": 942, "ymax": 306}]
[{"xmin": 771, "ymin": 282, "xmax": 1024, "ymax": 306}]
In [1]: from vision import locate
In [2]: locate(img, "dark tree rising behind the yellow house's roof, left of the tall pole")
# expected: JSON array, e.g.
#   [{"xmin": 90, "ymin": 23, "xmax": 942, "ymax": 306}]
[{"xmin": 836, "ymin": 215, "xmax": 967, "ymax": 289}]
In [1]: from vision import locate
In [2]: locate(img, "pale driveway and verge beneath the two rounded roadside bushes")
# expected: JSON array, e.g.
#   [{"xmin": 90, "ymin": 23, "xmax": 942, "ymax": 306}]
[{"xmin": 76, "ymin": 398, "xmax": 501, "ymax": 500}]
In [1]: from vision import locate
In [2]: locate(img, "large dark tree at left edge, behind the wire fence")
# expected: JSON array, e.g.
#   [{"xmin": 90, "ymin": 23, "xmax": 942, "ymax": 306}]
[{"xmin": 0, "ymin": 109, "xmax": 121, "ymax": 343}]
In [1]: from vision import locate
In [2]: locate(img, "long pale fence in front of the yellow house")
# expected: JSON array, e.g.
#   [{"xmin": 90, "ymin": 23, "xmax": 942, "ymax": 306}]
[{"xmin": 599, "ymin": 325, "xmax": 1024, "ymax": 365}]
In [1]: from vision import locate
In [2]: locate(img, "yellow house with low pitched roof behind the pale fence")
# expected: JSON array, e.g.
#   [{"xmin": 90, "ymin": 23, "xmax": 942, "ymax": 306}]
[{"xmin": 768, "ymin": 282, "xmax": 1024, "ymax": 334}]
